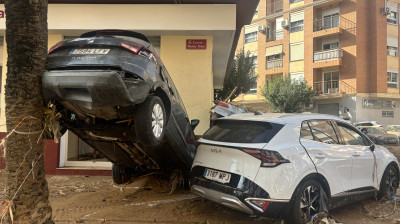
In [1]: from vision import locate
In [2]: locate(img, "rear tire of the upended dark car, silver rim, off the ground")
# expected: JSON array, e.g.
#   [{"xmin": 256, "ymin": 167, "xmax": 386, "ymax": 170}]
[{"xmin": 135, "ymin": 96, "xmax": 167, "ymax": 146}]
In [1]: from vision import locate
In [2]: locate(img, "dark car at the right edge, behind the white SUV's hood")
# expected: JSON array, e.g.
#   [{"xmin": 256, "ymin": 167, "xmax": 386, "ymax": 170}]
[{"xmin": 358, "ymin": 126, "xmax": 399, "ymax": 145}]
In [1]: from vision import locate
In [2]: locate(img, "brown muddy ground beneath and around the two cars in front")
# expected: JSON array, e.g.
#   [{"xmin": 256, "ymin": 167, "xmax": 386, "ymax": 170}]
[{"xmin": 0, "ymin": 147, "xmax": 400, "ymax": 224}]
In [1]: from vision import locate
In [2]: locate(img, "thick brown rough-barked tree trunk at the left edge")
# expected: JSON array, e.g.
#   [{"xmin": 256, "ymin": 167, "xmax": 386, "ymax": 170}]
[{"xmin": 4, "ymin": 0, "xmax": 53, "ymax": 223}]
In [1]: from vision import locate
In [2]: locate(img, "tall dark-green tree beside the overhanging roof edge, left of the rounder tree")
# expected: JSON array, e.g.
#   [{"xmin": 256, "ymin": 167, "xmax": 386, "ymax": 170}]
[{"xmin": 217, "ymin": 51, "xmax": 258, "ymax": 101}]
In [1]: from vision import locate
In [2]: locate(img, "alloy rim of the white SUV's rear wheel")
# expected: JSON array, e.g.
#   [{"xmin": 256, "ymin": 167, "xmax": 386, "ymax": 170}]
[{"xmin": 300, "ymin": 186, "xmax": 320, "ymax": 220}]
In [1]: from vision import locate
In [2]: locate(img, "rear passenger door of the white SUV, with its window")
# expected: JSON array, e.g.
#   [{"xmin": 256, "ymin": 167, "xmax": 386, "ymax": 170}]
[{"xmin": 300, "ymin": 120, "xmax": 352, "ymax": 195}]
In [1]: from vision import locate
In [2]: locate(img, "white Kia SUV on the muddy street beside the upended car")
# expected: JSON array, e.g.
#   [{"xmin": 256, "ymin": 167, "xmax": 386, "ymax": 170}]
[{"xmin": 190, "ymin": 114, "xmax": 399, "ymax": 223}]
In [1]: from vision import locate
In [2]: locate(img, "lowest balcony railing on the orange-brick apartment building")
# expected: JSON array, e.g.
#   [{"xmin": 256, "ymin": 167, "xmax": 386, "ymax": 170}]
[{"xmin": 313, "ymin": 80, "xmax": 356, "ymax": 95}]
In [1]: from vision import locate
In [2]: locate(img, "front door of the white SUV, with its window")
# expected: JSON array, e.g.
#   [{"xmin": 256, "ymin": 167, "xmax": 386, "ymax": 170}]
[{"xmin": 336, "ymin": 122, "xmax": 378, "ymax": 189}]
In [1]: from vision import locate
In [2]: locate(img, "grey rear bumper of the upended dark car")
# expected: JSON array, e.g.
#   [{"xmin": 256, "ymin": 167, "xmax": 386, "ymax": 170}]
[{"xmin": 42, "ymin": 70, "xmax": 151, "ymax": 109}]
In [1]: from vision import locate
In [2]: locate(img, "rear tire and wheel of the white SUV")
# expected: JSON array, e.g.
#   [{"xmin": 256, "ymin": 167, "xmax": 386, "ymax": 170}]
[{"xmin": 286, "ymin": 179, "xmax": 328, "ymax": 224}]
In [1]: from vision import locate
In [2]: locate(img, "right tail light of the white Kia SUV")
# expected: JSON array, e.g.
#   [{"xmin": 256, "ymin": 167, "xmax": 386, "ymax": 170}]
[{"xmin": 243, "ymin": 149, "xmax": 290, "ymax": 167}]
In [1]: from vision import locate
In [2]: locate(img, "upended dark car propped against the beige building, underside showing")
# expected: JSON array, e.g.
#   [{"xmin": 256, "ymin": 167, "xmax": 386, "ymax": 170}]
[{"xmin": 42, "ymin": 30, "xmax": 198, "ymax": 183}]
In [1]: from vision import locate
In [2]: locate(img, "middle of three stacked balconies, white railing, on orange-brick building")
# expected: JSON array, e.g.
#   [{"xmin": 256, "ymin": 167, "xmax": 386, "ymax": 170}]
[{"xmin": 314, "ymin": 49, "xmax": 343, "ymax": 68}]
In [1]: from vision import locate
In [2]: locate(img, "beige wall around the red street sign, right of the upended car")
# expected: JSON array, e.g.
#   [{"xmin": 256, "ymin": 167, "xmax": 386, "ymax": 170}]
[{"xmin": 161, "ymin": 36, "xmax": 213, "ymax": 135}]
